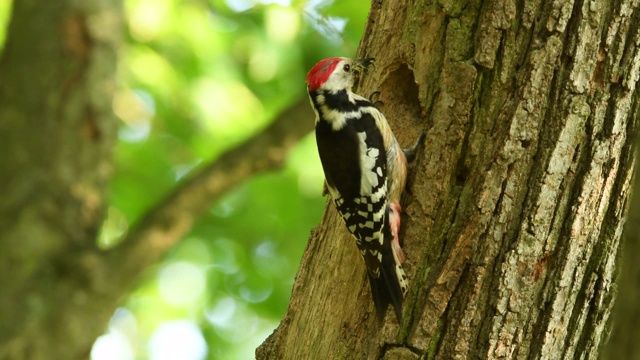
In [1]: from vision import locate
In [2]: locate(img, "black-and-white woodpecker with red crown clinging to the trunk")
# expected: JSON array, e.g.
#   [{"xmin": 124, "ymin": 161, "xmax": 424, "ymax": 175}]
[{"xmin": 306, "ymin": 57, "xmax": 422, "ymax": 324}]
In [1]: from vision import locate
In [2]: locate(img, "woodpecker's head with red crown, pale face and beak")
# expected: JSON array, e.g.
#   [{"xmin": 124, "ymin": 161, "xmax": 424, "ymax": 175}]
[{"xmin": 306, "ymin": 57, "xmax": 374, "ymax": 92}]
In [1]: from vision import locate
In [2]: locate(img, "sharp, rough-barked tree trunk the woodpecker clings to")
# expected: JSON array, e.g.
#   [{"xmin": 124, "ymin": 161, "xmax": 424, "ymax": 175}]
[{"xmin": 257, "ymin": 0, "xmax": 640, "ymax": 359}]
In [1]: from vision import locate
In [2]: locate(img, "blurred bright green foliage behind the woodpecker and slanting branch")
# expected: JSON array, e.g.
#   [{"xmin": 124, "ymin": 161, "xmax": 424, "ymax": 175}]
[{"xmin": 92, "ymin": 0, "xmax": 368, "ymax": 360}]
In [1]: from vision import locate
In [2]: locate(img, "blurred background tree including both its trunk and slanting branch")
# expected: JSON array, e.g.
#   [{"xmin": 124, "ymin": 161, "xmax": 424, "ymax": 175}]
[{"xmin": 0, "ymin": 0, "xmax": 313, "ymax": 360}]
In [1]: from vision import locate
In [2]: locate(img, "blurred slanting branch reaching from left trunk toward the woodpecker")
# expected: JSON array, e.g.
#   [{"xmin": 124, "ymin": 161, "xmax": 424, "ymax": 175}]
[{"xmin": 105, "ymin": 98, "xmax": 313, "ymax": 287}]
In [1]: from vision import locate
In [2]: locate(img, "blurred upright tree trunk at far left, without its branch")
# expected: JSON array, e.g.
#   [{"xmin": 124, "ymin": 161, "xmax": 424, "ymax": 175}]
[{"xmin": 0, "ymin": 0, "xmax": 122, "ymax": 360}]
